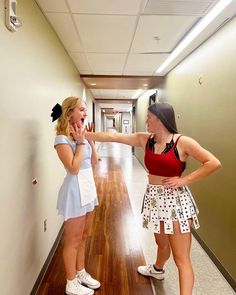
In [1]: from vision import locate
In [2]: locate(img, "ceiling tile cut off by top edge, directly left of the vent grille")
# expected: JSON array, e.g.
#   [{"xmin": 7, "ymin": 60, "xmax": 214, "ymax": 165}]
[{"xmin": 67, "ymin": 0, "xmax": 142, "ymax": 15}]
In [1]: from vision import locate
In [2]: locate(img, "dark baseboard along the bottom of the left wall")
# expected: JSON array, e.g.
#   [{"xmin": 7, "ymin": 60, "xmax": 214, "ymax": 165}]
[{"xmin": 30, "ymin": 224, "xmax": 64, "ymax": 295}]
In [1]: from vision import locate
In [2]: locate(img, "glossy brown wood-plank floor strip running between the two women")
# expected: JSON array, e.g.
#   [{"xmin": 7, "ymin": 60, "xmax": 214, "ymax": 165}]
[{"xmin": 37, "ymin": 157, "xmax": 153, "ymax": 295}]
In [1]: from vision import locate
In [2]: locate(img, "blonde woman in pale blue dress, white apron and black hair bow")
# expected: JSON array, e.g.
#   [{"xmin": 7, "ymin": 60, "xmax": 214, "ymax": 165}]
[{"xmin": 51, "ymin": 97, "xmax": 100, "ymax": 295}]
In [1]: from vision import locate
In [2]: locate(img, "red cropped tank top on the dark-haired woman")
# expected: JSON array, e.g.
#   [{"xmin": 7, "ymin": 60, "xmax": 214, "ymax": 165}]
[{"xmin": 144, "ymin": 135, "xmax": 185, "ymax": 177}]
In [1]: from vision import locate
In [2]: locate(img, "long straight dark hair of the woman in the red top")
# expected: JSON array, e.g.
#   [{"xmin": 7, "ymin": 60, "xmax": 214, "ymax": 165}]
[{"xmin": 148, "ymin": 102, "xmax": 178, "ymax": 133}]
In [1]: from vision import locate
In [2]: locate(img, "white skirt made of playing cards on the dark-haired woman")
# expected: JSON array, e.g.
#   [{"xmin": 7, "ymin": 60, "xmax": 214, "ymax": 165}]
[{"xmin": 142, "ymin": 184, "xmax": 199, "ymax": 234}]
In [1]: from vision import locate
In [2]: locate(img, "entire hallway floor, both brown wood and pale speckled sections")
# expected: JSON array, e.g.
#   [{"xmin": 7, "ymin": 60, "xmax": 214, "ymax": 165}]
[{"xmin": 37, "ymin": 143, "xmax": 235, "ymax": 295}]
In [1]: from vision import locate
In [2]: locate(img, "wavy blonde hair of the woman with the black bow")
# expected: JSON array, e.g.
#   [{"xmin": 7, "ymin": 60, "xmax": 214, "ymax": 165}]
[{"xmin": 56, "ymin": 96, "xmax": 84, "ymax": 137}]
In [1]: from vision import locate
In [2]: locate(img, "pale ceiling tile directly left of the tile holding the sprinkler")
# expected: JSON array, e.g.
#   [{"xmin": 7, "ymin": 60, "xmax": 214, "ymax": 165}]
[{"xmin": 74, "ymin": 15, "xmax": 136, "ymax": 53}]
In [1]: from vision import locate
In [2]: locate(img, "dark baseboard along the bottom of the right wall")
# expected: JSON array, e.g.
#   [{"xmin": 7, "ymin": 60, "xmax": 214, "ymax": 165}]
[{"xmin": 192, "ymin": 230, "xmax": 236, "ymax": 291}]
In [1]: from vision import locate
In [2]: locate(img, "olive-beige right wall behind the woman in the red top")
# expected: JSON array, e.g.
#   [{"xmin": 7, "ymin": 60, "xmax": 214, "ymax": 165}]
[{"xmin": 166, "ymin": 18, "xmax": 236, "ymax": 279}]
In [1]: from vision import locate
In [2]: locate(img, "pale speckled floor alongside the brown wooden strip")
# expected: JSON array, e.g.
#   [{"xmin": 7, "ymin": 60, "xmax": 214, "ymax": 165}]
[{"xmin": 98, "ymin": 143, "xmax": 236, "ymax": 295}]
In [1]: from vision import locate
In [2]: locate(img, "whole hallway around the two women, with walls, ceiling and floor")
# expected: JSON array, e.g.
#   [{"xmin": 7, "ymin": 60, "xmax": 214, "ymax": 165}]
[{"xmin": 0, "ymin": 0, "xmax": 236, "ymax": 295}]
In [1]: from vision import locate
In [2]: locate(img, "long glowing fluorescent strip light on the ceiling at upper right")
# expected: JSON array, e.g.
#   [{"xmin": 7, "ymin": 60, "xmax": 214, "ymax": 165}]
[{"xmin": 156, "ymin": 0, "xmax": 232, "ymax": 73}]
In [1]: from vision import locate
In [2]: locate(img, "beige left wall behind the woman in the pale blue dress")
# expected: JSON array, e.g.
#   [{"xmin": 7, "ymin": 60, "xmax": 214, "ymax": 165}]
[{"xmin": 0, "ymin": 0, "xmax": 92, "ymax": 295}]
